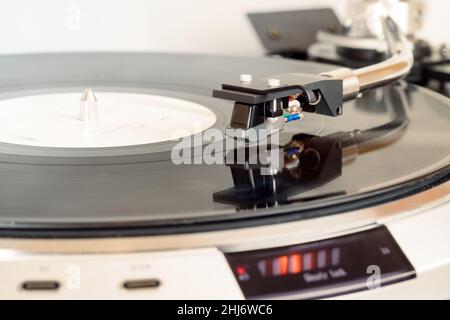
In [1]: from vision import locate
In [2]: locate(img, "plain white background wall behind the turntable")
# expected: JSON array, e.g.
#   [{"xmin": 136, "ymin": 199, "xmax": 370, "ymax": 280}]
[{"xmin": 0, "ymin": 0, "xmax": 450, "ymax": 55}]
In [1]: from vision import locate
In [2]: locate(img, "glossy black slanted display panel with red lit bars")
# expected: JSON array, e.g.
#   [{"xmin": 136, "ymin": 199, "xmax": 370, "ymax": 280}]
[{"xmin": 226, "ymin": 227, "xmax": 415, "ymax": 299}]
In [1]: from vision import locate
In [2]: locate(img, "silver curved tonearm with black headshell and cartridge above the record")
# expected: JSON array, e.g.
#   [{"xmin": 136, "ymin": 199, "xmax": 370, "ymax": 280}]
[{"xmin": 213, "ymin": 17, "xmax": 413, "ymax": 138}]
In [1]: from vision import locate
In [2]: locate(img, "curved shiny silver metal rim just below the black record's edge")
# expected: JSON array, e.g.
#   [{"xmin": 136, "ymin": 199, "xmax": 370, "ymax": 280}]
[{"xmin": 0, "ymin": 181, "xmax": 450, "ymax": 255}]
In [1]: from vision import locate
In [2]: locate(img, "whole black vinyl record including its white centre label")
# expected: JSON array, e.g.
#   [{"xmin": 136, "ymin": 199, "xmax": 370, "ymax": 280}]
[{"xmin": 0, "ymin": 53, "xmax": 450, "ymax": 237}]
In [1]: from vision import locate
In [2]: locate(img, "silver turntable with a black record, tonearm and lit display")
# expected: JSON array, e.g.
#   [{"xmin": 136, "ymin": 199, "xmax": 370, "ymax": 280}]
[{"xmin": 0, "ymin": 17, "xmax": 450, "ymax": 299}]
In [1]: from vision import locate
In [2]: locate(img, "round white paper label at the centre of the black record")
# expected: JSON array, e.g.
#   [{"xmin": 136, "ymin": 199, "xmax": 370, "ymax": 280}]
[{"xmin": 0, "ymin": 92, "xmax": 216, "ymax": 148}]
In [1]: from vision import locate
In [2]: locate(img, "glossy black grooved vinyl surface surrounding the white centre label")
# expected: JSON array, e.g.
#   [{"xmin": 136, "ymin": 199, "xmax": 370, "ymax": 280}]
[{"xmin": 0, "ymin": 53, "xmax": 450, "ymax": 234}]
